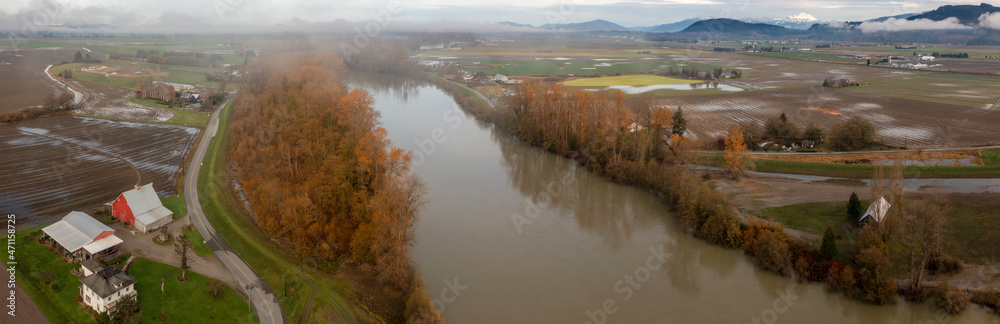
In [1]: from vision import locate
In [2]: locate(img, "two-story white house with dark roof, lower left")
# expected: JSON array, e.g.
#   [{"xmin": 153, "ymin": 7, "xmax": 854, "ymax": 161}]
[{"xmin": 80, "ymin": 260, "xmax": 138, "ymax": 313}]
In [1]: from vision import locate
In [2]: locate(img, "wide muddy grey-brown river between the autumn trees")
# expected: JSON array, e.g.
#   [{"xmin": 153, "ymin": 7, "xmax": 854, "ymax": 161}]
[{"xmin": 351, "ymin": 74, "xmax": 998, "ymax": 323}]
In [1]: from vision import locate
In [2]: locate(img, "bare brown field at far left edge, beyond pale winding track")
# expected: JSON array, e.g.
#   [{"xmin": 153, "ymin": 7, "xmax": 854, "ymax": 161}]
[{"xmin": 0, "ymin": 46, "xmax": 79, "ymax": 113}]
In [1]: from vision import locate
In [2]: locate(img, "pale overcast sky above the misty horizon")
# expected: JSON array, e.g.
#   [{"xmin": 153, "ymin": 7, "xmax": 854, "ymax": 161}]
[{"xmin": 0, "ymin": 0, "xmax": 988, "ymax": 29}]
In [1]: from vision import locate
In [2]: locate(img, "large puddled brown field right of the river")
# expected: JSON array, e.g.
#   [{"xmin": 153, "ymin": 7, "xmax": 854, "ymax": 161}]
[{"xmin": 662, "ymin": 87, "xmax": 1000, "ymax": 147}]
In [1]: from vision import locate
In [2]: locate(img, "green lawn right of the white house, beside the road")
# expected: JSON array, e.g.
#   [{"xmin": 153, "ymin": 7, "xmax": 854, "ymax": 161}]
[{"xmin": 129, "ymin": 258, "xmax": 258, "ymax": 323}]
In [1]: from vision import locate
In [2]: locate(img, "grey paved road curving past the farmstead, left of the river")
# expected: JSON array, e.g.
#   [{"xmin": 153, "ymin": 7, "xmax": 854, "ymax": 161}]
[{"xmin": 184, "ymin": 99, "xmax": 285, "ymax": 323}]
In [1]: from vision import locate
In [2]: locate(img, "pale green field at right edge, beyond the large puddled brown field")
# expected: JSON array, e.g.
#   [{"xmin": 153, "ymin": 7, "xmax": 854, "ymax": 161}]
[{"xmin": 844, "ymin": 72, "xmax": 1000, "ymax": 108}]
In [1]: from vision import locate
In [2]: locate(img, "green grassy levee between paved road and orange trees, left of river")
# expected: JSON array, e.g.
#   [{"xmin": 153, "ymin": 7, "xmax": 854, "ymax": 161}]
[{"xmin": 198, "ymin": 100, "xmax": 364, "ymax": 323}]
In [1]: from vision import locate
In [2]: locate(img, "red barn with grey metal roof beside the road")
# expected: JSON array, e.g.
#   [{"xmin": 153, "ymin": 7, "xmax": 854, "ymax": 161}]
[{"xmin": 111, "ymin": 183, "xmax": 174, "ymax": 233}]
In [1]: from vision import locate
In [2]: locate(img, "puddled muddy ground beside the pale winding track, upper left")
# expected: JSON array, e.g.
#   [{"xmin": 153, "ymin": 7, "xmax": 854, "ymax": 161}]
[{"xmin": 69, "ymin": 79, "xmax": 174, "ymax": 121}]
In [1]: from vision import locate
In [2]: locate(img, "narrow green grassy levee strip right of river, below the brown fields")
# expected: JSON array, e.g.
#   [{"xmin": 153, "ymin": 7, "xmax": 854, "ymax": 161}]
[{"xmin": 705, "ymin": 155, "xmax": 1000, "ymax": 179}]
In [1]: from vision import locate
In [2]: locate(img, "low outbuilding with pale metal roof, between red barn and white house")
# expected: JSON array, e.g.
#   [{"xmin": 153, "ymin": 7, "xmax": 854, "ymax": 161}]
[{"xmin": 42, "ymin": 211, "xmax": 123, "ymax": 263}]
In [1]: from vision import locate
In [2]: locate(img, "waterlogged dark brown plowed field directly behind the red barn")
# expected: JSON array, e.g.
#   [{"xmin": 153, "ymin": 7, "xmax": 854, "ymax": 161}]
[{"xmin": 0, "ymin": 116, "xmax": 198, "ymax": 226}]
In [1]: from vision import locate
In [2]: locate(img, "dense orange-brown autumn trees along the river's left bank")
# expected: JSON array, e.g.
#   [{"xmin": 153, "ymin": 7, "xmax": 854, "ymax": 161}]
[{"xmin": 229, "ymin": 52, "xmax": 440, "ymax": 322}]
